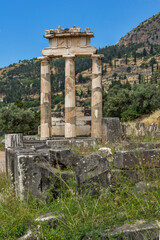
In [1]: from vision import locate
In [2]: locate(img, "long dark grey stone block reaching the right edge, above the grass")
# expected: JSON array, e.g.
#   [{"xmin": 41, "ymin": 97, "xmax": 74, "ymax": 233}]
[{"xmin": 113, "ymin": 149, "xmax": 160, "ymax": 169}]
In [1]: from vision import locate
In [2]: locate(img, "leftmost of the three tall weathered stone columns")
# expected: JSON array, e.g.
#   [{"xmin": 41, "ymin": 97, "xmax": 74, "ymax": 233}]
[{"xmin": 41, "ymin": 58, "xmax": 52, "ymax": 139}]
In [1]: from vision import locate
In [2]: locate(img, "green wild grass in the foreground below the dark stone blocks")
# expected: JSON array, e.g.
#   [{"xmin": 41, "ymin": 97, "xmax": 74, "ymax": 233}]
[{"xmin": 0, "ymin": 166, "xmax": 160, "ymax": 240}]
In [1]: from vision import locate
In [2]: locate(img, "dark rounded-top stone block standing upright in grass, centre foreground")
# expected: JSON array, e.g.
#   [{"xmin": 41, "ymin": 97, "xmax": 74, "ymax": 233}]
[{"xmin": 76, "ymin": 154, "xmax": 110, "ymax": 194}]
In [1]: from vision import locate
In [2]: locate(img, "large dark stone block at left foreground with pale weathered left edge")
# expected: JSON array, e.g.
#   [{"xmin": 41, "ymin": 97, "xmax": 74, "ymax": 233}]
[{"xmin": 14, "ymin": 149, "xmax": 73, "ymax": 200}]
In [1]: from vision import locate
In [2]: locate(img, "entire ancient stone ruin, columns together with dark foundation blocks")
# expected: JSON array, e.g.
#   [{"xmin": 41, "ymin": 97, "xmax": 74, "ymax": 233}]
[{"xmin": 2, "ymin": 27, "xmax": 160, "ymax": 239}]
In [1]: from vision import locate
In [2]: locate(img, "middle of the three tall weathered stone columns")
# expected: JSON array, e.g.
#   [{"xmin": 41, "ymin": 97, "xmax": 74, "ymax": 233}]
[{"xmin": 64, "ymin": 55, "xmax": 76, "ymax": 138}]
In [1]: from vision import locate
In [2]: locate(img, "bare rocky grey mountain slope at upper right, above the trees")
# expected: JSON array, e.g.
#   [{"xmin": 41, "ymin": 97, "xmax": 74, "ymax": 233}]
[{"xmin": 118, "ymin": 13, "xmax": 160, "ymax": 46}]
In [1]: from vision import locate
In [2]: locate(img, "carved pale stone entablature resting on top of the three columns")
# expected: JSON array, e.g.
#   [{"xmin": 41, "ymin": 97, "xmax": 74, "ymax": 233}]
[{"xmin": 42, "ymin": 26, "xmax": 96, "ymax": 57}]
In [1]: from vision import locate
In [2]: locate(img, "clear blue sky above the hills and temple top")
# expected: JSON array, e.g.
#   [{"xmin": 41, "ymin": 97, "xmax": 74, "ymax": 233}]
[{"xmin": 0, "ymin": 0, "xmax": 160, "ymax": 68}]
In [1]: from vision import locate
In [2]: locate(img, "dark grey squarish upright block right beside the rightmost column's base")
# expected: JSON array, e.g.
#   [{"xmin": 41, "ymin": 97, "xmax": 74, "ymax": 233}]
[{"xmin": 102, "ymin": 118, "xmax": 122, "ymax": 143}]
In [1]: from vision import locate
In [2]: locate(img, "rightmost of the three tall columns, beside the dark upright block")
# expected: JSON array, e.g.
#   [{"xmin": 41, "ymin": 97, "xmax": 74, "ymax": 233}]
[{"xmin": 91, "ymin": 54, "xmax": 103, "ymax": 138}]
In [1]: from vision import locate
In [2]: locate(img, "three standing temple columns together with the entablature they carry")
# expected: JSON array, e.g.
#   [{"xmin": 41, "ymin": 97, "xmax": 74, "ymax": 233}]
[{"xmin": 38, "ymin": 26, "xmax": 103, "ymax": 139}]
